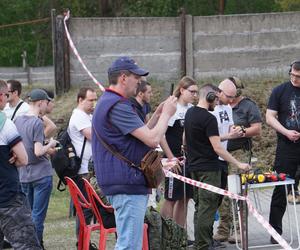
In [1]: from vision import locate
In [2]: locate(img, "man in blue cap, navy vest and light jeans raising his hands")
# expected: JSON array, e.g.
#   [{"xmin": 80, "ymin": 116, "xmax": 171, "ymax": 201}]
[{"xmin": 92, "ymin": 57, "xmax": 176, "ymax": 250}]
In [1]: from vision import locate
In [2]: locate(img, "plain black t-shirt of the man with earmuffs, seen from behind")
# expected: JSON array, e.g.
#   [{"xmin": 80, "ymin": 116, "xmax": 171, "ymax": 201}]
[{"xmin": 184, "ymin": 106, "xmax": 220, "ymax": 172}]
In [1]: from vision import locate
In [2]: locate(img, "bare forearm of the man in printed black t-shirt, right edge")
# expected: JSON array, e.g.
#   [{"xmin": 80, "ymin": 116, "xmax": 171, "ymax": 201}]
[{"xmin": 266, "ymin": 109, "xmax": 300, "ymax": 141}]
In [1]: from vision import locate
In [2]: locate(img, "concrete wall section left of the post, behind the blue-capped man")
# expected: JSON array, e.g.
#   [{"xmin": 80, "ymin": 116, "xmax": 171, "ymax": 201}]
[{"xmin": 70, "ymin": 17, "xmax": 181, "ymax": 84}]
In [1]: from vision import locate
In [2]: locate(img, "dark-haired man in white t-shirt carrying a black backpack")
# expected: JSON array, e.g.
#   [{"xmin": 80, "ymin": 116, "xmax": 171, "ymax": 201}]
[{"xmin": 68, "ymin": 87, "xmax": 97, "ymax": 249}]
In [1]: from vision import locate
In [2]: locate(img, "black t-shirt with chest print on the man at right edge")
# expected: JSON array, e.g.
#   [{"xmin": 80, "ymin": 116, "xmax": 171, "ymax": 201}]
[{"xmin": 268, "ymin": 81, "xmax": 300, "ymax": 141}]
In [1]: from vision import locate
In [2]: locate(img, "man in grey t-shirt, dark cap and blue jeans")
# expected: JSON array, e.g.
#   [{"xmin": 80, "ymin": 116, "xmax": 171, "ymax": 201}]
[{"xmin": 15, "ymin": 89, "xmax": 57, "ymax": 248}]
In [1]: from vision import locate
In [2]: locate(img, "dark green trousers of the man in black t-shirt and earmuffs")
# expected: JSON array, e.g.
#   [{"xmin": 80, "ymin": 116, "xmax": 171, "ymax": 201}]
[{"xmin": 191, "ymin": 171, "xmax": 221, "ymax": 250}]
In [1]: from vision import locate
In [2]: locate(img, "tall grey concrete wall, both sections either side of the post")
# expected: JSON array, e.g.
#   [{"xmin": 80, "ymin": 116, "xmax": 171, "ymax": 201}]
[{"xmin": 69, "ymin": 12, "xmax": 300, "ymax": 84}]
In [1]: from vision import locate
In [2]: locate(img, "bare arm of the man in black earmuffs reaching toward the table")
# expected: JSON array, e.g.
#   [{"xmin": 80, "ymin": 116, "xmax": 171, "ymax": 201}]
[{"xmin": 209, "ymin": 136, "xmax": 251, "ymax": 170}]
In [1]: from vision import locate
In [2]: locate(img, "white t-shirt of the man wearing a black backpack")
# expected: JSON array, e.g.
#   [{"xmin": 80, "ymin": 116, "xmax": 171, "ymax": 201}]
[{"xmin": 68, "ymin": 108, "xmax": 92, "ymax": 174}]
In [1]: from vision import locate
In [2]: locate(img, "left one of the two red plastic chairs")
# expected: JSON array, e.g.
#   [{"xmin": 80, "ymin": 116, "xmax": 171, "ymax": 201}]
[{"xmin": 65, "ymin": 177, "xmax": 100, "ymax": 250}]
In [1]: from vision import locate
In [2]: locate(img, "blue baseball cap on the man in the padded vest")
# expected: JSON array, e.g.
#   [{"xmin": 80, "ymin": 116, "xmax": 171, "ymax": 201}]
[{"xmin": 108, "ymin": 56, "xmax": 149, "ymax": 76}]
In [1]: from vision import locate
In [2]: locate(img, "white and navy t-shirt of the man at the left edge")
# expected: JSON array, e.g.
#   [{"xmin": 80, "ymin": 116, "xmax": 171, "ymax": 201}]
[{"xmin": 0, "ymin": 116, "xmax": 22, "ymax": 207}]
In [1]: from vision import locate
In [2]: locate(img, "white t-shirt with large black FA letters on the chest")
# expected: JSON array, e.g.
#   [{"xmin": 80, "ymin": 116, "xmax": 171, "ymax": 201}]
[{"xmin": 211, "ymin": 105, "xmax": 234, "ymax": 161}]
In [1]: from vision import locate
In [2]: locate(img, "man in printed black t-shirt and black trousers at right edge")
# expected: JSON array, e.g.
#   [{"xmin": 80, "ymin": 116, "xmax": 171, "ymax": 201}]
[{"xmin": 266, "ymin": 61, "xmax": 300, "ymax": 244}]
